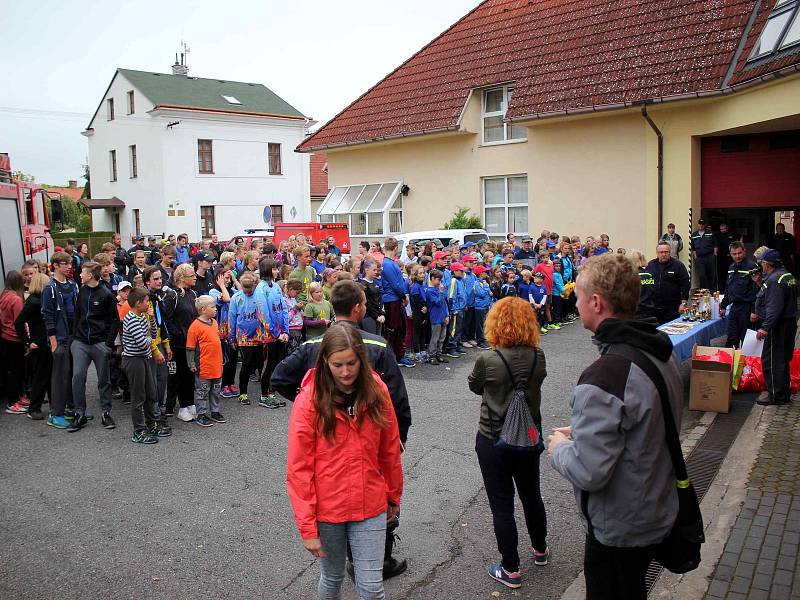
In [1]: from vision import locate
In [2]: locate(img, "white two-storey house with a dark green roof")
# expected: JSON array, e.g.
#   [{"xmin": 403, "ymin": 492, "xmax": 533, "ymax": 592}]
[{"xmin": 83, "ymin": 63, "xmax": 314, "ymax": 240}]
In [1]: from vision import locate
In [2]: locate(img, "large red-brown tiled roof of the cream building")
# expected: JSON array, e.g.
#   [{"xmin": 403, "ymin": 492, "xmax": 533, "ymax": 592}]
[{"xmin": 298, "ymin": 0, "xmax": 800, "ymax": 152}]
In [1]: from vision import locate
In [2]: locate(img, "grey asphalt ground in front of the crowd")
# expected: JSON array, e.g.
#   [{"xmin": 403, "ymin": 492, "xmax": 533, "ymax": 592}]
[{"xmin": 0, "ymin": 324, "xmax": 596, "ymax": 600}]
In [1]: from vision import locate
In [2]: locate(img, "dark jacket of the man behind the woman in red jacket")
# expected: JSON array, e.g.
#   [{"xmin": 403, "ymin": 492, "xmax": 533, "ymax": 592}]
[{"xmin": 270, "ymin": 320, "xmax": 411, "ymax": 444}]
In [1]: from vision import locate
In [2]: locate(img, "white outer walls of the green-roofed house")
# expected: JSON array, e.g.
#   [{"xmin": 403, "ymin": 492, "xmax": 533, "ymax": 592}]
[{"xmin": 89, "ymin": 74, "xmax": 311, "ymax": 241}]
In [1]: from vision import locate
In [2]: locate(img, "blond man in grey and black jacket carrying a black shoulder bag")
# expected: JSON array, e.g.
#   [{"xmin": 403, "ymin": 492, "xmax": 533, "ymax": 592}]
[{"xmin": 548, "ymin": 254, "xmax": 683, "ymax": 600}]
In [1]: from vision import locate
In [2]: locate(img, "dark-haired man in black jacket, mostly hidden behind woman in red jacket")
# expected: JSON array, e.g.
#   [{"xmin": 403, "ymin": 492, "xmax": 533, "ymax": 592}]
[{"xmin": 270, "ymin": 281, "xmax": 411, "ymax": 579}]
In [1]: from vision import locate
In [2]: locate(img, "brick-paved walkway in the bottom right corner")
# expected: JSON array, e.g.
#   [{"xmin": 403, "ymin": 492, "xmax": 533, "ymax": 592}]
[{"xmin": 705, "ymin": 400, "xmax": 800, "ymax": 600}]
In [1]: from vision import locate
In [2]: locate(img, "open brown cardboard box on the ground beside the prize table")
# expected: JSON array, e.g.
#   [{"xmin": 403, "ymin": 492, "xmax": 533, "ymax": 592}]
[{"xmin": 689, "ymin": 346, "xmax": 734, "ymax": 413}]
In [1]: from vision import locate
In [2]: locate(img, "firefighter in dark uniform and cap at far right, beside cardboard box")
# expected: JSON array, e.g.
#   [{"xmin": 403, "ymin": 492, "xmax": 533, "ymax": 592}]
[{"xmin": 756, "ymin": 250, "xmax": 797, "ymax": 404}]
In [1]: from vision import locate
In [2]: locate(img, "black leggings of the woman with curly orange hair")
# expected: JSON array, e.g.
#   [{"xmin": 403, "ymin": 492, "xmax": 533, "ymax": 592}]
[{"xmin": 475, "ymin": 433, "xmax": 547, "ymax": 573}]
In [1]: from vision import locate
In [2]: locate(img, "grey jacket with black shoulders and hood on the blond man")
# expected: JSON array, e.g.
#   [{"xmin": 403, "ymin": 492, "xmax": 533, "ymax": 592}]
[{"xmin": 552, "ymin": 319, "xmax": 683, "ymax": 547}]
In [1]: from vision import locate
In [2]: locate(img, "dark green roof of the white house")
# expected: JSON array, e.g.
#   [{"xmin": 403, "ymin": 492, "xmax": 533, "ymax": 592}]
[{"xmin": 118, "ymin": 69, "xmax": 304, "ymax": 118}]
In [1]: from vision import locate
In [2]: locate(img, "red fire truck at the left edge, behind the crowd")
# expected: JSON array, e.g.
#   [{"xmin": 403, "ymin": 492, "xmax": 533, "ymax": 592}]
[{"xmin": 0, "ymin": 153, "xmax": 54, "ymax": 288}]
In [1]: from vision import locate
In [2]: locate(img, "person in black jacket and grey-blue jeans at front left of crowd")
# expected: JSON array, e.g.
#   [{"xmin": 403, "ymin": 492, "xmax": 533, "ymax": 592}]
[{"xmin": 67, "ymin": 262, "xmax": 120, "ymax": 432}]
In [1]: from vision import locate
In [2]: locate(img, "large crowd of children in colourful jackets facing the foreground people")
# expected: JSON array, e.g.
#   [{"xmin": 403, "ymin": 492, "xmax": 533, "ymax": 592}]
[{"xmin": 0, "ymin": 232, "xmax": 608, "ymax": 444}]
